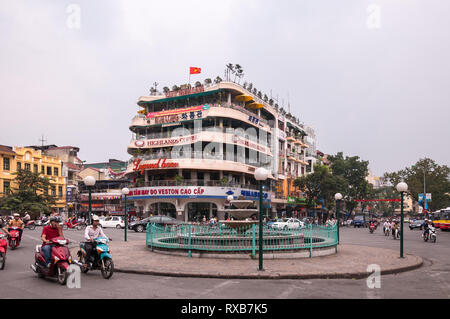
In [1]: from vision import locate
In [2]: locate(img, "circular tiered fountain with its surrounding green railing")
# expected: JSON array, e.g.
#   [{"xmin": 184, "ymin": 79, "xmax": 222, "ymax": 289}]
[{"xmin": 146, "ymin": 195, "xmax": 337, "ymax": 258}]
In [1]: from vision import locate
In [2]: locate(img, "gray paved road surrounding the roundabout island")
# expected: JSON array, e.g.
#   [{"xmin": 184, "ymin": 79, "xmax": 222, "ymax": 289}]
[{"xmin": 0, "ymin": 228, "xmax": 450, "ymax": 299}]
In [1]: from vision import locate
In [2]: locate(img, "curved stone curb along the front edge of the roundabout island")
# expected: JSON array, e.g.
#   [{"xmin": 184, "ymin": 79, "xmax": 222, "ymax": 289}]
[{"xmin": 114, "ymin": 256, "xmax": 423, "ymax": 279}]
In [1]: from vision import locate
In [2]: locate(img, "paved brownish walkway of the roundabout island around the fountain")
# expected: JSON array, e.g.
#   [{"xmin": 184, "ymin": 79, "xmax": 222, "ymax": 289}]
[{"xmin": 71, "ymin": 240, "xmax": 423, "ymax": 279}]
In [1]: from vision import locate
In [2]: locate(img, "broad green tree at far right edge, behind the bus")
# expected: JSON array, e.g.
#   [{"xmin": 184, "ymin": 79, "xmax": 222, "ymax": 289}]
[{"xmin": 384, "ymin": 158, "xmax": 450, "ymax": 211}]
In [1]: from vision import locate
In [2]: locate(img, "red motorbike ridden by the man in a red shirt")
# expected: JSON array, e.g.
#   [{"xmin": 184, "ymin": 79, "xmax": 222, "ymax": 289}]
[{"xmin": 31, "ymin": 237, "xmax": 72, "ymax": 285}]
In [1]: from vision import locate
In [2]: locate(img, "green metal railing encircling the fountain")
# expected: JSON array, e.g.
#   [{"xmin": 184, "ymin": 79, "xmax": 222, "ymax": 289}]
[{"xmin": 146, "ymin": 223, "xmax": 338, "ymax": 257}]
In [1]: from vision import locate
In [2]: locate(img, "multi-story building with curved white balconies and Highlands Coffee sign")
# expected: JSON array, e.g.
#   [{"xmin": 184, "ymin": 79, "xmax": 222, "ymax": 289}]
[{"xmin": 126, "ymin": 82, "xmax": 316, "ymax": 221}]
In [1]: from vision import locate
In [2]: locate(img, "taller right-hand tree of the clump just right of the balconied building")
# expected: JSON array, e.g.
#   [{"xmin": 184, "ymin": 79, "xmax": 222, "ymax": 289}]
[{"xmin": 328, "ymin": 152, "xmax": 372, "ymax": 213}]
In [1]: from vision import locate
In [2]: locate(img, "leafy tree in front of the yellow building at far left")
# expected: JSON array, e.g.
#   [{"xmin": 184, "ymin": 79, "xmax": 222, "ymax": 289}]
[{"xmin": 0, "ymin": 170, "xmax": 56, "ymax": 217}]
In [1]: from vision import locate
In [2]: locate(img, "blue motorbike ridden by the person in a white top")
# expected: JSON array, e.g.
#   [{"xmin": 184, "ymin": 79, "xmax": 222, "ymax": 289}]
[{"xmin": 77, "ymin": 237, "xmax": 114, "ymax": 279}]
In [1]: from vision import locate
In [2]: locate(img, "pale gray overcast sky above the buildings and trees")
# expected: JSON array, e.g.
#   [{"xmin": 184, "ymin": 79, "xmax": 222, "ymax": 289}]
[{"xmin": 0, "ymin": 0, "xmax": 450, "ymax": 175}]
